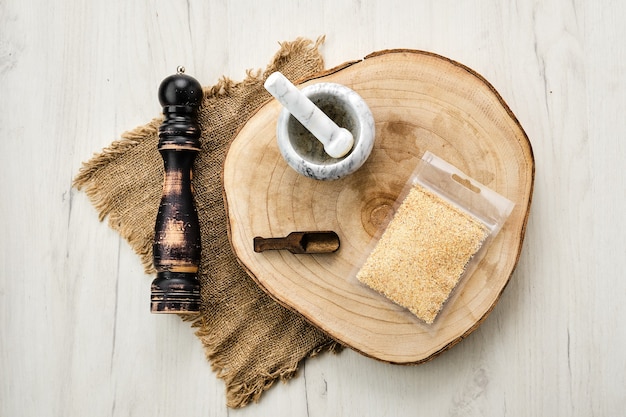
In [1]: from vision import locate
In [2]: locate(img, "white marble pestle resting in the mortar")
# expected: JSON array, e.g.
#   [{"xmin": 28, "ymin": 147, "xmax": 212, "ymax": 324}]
[{"xmin": 264, "ymin": 72, "xmax": 354, "ymax": 158}]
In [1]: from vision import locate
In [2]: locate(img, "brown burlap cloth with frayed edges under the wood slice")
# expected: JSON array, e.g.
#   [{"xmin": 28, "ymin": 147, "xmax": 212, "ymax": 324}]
[{"xmin": 74, "ymin": 38, "xmax": 340, "ymax": 407}]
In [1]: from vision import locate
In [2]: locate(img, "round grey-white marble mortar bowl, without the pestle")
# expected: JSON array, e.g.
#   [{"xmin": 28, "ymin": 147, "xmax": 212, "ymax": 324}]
[{"xmin": 276, "ymin": 83, "xmax": 375, "ymax": 180}]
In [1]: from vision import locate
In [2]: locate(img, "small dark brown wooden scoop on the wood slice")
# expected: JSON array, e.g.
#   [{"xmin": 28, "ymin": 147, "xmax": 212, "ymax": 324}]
[{"xmin": 254, "ymin": 231, "xmax": 339, "ymax": 254}]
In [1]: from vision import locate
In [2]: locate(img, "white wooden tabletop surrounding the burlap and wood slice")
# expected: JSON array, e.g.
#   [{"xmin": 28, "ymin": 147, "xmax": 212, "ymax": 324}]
[{"xmin": 0, "ymin": 0, "xmax": 626, "ymax": 417}]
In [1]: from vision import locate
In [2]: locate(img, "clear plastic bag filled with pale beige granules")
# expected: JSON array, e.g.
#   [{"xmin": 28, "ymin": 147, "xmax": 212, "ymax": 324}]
[{"xmin": 355, "ymin": 152, "xmax": 514, "ymax": 327}]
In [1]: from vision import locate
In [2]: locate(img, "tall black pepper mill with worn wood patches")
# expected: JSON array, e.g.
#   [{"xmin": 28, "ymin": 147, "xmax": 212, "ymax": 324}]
[{"xmin": 150, "ymin": 67, "xmax": 202, "ymax": 314}]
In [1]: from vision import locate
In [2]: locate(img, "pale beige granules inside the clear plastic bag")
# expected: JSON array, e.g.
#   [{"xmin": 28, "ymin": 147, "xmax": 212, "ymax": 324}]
[{"xmin": 357, "ymin": 185, "xmax": 490, "ymax": 324}]
